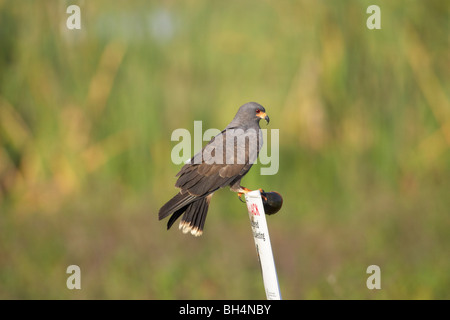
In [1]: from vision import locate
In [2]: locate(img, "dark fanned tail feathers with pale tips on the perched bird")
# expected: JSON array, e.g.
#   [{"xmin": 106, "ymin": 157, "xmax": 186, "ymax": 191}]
[{"xmin": 159, "ymin": 193, "xmax": 212, "ymax": 237}]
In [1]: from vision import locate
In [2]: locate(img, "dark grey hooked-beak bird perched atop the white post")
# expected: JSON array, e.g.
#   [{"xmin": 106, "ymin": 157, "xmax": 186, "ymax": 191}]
[{"xmin": 159, "ymin": 102, "xmax": 270, "ymax": 236}]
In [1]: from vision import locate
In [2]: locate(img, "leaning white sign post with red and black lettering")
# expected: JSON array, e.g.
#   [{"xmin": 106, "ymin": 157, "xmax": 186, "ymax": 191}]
[{"xmin": 245, "ymin": 190, "xmax": 281, "ymax": 300}]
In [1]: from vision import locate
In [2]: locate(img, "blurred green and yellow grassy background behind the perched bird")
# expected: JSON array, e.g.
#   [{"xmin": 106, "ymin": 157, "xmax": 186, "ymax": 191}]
[{"xmin": 0, "ymin": 0, "xmax": 450, "ymax": 299}]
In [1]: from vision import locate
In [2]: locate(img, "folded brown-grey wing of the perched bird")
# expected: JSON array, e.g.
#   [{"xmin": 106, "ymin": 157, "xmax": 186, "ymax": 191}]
[{"xmin": 175, "ymin": 128, "xmax": 260, "ymax": 196}]
